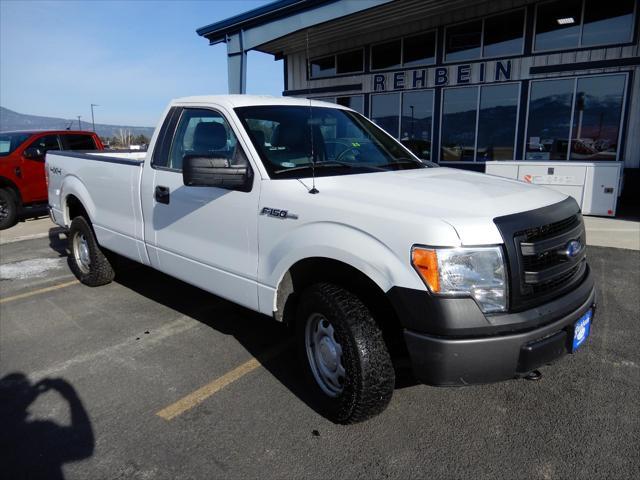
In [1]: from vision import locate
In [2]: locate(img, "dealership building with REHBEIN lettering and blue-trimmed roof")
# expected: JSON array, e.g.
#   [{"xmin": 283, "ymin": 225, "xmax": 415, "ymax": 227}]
[{"xmin": 197, "ymin": 0, "xmax": 640, "ymax": 204}]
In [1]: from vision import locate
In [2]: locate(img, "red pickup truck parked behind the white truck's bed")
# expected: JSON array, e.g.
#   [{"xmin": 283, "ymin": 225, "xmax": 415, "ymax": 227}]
[{"xmin": 0, "ymin": 130, "xmax": 104, "ymax": 230}]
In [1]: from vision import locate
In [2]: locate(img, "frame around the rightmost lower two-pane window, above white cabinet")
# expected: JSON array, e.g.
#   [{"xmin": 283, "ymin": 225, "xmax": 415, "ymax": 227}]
[{"xmin": 522, "ymin": 71, "xmax": 629, "ymax": 163}]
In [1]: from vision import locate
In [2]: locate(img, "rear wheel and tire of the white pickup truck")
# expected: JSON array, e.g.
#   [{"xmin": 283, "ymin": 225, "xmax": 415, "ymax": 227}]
[{"xmin": 68, "ymin": 217, "xmax": 115, "ymax": 287}]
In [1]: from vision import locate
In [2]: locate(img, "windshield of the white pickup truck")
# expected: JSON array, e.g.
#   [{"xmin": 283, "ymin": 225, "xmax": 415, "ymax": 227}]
[{"xmin": 235, "ymin": 105, "xmax": 432, "ymax": 178}]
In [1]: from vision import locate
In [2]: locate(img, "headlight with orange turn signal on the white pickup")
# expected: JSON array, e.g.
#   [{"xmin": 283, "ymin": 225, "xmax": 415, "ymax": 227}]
[{"xmin": 411, "ymin": 247, "xmax": 507, "ymax": 313}]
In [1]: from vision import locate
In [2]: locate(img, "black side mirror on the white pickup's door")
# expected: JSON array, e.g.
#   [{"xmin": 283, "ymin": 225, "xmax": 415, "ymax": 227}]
[{"xmin": 182, "ymin": 155, "xmax": 251, "ymax": 192}]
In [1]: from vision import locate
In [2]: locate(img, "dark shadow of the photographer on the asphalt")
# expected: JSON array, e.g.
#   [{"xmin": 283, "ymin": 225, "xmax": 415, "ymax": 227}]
[{"xmin": 0, "ymin": 373, "xmax": 95, "ymax": 480}]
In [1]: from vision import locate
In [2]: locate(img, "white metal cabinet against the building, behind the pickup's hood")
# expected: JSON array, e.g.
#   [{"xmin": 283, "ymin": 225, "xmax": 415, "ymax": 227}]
[{"xmin": 486, "ymin": 160, "xmax": 622, "ymax": 217}]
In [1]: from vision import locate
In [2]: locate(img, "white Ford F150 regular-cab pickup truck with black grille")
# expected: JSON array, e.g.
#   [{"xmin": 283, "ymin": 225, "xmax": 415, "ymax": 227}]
[{"xmin": 46, "ymin": 96, "xmax": 595, "ymax": 423}]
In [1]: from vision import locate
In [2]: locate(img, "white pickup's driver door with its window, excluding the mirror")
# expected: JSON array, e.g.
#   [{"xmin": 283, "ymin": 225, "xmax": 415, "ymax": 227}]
[{"xmin": 142, "ymin": 107, "xmax": 260, "ymax": 309}]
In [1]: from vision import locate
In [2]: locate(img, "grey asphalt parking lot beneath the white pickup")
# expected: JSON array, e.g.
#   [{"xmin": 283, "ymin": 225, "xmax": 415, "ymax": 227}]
[{"xmin": 0, "ymin": 227, "xmax": 640, "ymax": 479}]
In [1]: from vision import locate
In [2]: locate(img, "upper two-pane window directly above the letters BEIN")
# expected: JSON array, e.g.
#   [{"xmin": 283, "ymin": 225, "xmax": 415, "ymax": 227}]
[{"xmin": 445, "ymin": 9, "xmax": 525, "ymax": 62}]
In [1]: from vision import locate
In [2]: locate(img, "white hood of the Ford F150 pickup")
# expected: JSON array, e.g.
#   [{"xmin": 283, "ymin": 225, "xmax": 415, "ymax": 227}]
[{"xmin": 312, "ymin": 167, "xmax": 566, "ymax": 245}]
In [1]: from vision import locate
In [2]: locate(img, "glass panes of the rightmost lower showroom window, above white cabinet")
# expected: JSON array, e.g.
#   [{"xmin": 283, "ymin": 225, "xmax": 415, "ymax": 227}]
[{"xmin": 525, "ymin": 74, "xmax": 627, "ymax": 160}]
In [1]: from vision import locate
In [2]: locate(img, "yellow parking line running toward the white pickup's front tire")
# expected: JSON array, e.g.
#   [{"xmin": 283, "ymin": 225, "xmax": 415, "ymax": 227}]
[{"xmin": 156, "ymin": 342, "xmax": 289, "ymax": 421}]
